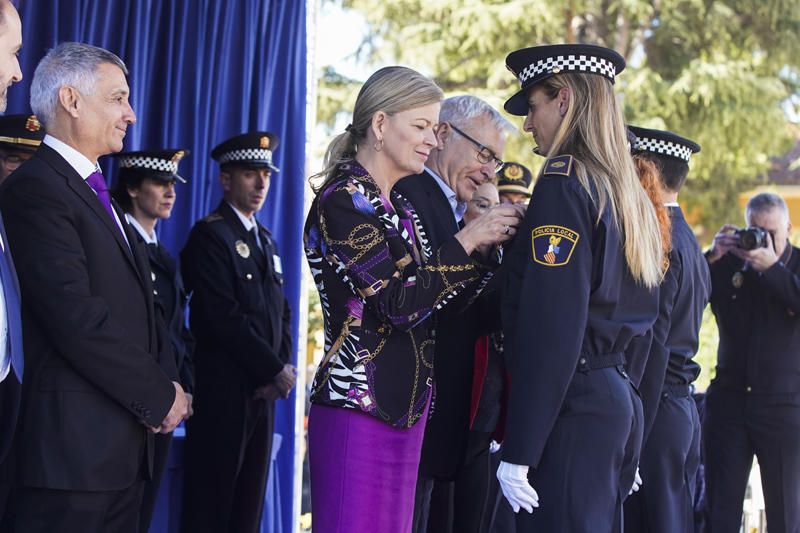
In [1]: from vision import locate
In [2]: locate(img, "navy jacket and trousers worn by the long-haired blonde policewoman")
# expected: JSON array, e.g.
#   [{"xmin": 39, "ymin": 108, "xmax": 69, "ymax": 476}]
[{"xmin": 502, "ymin": 155, "xmax": 657, "ymax": 533}]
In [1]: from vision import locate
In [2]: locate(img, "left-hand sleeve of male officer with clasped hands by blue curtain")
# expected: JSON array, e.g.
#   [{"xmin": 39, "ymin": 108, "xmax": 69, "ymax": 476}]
[{"xmin": 181, "ymin": 222, "xmax": 283, "ymax": 386}]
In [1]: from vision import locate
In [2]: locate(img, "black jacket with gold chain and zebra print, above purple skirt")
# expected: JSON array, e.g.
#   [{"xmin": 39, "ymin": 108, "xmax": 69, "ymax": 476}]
[{"xmin": 304, "ymin": 163, "xmax": 483, "ymax": 427}]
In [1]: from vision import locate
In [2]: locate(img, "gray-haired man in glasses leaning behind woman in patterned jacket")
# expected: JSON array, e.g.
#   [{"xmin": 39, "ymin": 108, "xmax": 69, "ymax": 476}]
[{"xmin": 396, "ymin": 95, "xmax": 512, "ymax": 533}]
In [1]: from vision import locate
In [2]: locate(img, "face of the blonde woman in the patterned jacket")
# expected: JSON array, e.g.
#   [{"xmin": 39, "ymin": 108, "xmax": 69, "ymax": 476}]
[{"xmin": 380, "ymin": 102, "xmax": 441, "ymax": 177}]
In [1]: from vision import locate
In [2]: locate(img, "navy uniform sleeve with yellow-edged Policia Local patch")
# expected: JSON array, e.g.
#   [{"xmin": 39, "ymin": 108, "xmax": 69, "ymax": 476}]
[{"xmin": 502, "ymin": 176, "xmax": 594, "ymax": 467}]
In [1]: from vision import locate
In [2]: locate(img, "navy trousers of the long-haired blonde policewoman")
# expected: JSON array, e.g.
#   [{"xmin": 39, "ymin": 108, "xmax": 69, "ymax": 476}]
[{"xmin": 517, "ymin": 367, "xmax": 643, "ymax": 533}]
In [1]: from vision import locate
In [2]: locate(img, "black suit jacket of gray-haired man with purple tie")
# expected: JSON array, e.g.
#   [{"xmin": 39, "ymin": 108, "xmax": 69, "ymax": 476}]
[{"xmin": 0, "ymin": 145, "xmax": 175, "ymax": 491}]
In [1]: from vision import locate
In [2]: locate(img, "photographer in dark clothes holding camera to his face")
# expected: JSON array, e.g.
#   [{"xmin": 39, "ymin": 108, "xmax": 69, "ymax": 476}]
[{"xmin": 703, "ymin": 193, "xmax": 800, "ymax": 532}]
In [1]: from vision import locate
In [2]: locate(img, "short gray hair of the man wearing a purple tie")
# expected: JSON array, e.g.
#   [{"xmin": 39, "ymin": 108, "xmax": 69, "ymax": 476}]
[{"xmin": 31, "ymin": 42, "xmax": 128, "ymax": 126}]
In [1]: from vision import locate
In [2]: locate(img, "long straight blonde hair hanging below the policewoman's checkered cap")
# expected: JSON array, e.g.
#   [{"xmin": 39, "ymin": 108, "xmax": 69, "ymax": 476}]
[{"xmin": 539, "ymin": 72, "xmax": 663, "ymax": 287}]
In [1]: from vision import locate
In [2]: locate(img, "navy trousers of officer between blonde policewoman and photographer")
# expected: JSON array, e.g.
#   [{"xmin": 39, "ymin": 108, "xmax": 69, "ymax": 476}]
[{"xmin": 625, "ymin": 385, "xmax": 700, "ymax": 533}]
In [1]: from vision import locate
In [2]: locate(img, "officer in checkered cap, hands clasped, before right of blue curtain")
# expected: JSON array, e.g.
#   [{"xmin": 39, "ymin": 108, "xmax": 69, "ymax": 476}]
[{"xmin": 181, "ymin": 132, "xmax": 296, "ymax": 533}]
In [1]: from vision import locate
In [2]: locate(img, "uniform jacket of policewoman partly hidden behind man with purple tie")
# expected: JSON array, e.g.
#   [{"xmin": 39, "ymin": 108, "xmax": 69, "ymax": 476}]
[{"xmin": 134, "ymin": 231, "xmax": 194, "ymax": 393}]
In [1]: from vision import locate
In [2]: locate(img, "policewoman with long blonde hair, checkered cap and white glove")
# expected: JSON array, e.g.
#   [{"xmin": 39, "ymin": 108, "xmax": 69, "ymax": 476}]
[{"xmin": 497, "ymin": 45, "xmax": 663, "ymax": 533}]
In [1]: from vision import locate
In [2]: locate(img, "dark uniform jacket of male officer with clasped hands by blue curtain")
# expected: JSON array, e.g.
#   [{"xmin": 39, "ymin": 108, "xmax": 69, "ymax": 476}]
[{"xmin": 181, "ymin": 200, "xmax": 292, "ymax": 390}]
